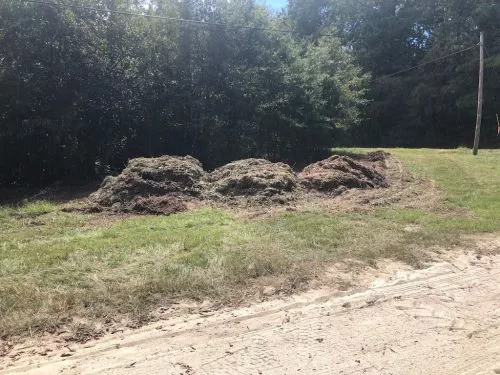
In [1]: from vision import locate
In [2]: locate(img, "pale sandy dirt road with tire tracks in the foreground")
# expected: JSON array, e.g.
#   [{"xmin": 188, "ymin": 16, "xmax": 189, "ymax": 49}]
[{"xmin": 0, "ymin": 248, "xmax": 500, "ymax": 375}]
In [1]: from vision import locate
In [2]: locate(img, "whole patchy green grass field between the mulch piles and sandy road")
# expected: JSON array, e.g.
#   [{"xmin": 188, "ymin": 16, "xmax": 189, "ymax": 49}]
[{"xmin": 0, "ymin": 149, "xmax": 500, "ymax": 338}]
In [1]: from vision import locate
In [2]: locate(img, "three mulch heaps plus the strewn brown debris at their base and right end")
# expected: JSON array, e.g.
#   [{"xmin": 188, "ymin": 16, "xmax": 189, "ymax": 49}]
[{"xmin": 78, "ymin": 151, "xmax": 439, "ymax": 214}]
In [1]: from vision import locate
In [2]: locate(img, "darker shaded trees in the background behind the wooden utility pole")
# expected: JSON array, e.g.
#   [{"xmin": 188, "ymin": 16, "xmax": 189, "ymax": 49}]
[{"xmin": 291, "ymin": 0, "xmax": 500, "ymax": 147}]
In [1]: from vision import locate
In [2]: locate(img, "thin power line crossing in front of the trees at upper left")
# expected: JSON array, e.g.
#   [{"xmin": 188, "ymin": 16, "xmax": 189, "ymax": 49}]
[{"xmin": 21, "ymin": 0, "xmax": 335, "ymax": 37}]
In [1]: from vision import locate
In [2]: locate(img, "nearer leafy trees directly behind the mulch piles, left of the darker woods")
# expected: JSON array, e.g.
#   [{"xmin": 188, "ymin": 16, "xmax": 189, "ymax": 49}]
[{"xmin": 0, "ymin": 0, "xmax": 364, "ymax": 182}]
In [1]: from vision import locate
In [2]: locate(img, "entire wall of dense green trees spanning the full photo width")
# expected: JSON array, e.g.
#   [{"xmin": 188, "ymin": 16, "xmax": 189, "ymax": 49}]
[{"xmin": 0, "ymin": 0, "xmax": 500, "ymax": 184}]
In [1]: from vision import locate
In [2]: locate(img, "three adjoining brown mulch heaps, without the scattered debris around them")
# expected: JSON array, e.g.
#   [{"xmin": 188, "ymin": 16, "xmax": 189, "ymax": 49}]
[{"xmin": 89, "ymin": 152, "xmax": 388, "ymax": 215}]
